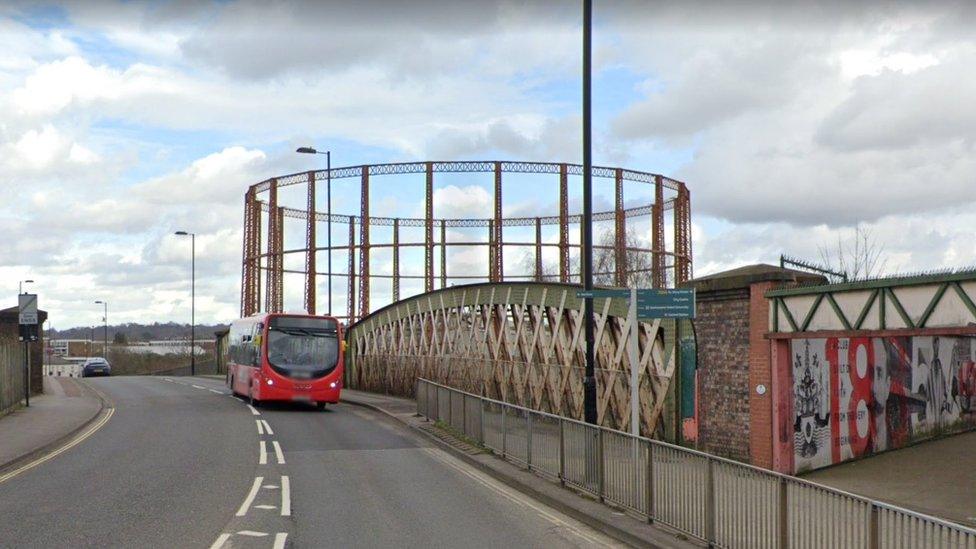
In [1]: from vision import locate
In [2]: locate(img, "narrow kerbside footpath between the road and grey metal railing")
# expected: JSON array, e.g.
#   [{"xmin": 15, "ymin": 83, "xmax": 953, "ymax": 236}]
[{"xmin": 342, "ymin": 388, "xmax": 703, "ymax": 549}]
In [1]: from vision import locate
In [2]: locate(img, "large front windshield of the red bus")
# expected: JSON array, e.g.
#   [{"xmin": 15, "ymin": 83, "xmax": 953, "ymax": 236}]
[{"xmin": 268, "ymin": 317, "xmax": 339, "ymax": 379}]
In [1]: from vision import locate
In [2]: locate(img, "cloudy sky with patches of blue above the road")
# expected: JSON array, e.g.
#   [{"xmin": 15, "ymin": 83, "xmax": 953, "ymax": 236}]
[{"xmin": 0, "ymin": 0, "xmax": 976, "ymax": 328}]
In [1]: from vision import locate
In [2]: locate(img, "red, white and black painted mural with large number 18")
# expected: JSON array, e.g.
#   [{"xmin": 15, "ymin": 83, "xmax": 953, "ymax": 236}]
[{"xmin": 777, "ymin": 336, "xmax": 976, "ymax": 472}]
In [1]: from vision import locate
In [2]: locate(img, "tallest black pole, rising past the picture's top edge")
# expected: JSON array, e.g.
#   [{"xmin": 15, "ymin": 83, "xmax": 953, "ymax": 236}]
[{"xmin": 582, "ymin": 0, "xmax": 597, "ymax": 424}]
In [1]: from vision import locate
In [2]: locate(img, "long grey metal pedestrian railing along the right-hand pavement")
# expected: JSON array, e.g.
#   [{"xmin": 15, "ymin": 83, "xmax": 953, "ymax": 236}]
[{"xmin": 416, "ymin": 379, "xmax": 976, "ymax": 549}]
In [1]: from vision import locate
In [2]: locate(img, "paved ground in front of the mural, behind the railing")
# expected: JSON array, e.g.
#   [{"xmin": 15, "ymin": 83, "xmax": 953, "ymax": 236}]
[{"xmin": 803, "ymin": 432, "xmax": 976, "ymax": 527}]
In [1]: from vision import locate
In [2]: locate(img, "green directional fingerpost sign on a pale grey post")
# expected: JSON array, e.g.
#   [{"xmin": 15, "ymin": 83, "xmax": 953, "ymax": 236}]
[{"xmin": 576, "ymin": 288, "xmax": 695, "ymax": 436}]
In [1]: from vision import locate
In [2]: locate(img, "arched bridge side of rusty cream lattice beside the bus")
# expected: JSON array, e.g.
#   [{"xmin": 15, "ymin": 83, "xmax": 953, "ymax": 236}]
[{"xmin": 346, "ymin": 282, "xmax": 691, "ymax": 436}]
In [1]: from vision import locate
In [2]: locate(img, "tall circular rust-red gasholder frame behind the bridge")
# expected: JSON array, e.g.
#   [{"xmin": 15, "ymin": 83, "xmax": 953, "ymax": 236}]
[{"xmin": 241, "ymin": 161, "xmax": 692, "ymax": 323}]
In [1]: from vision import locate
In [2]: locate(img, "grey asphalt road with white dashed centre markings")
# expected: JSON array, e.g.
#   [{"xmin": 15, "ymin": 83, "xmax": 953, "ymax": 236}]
[{"xmin": 0, "ymin": 377, "xmax": 614, "ymax": 548}]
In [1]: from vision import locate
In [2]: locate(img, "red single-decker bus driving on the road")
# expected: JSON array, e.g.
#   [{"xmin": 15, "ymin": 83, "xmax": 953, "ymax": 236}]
[{"xmin": 227, "ymin": 313, "xmax": 343, "ymax": 410}]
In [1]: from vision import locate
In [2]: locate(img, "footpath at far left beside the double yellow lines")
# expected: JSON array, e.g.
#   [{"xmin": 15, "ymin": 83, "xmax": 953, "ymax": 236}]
[{"xmin": 0, "ymin": 376, "xmax": 106, "ymax": 477}]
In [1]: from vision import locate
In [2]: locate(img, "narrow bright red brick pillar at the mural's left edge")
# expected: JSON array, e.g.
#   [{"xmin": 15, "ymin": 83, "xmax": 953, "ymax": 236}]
[{"xmin": 749, "ymin": 282, "xmax": 774, "ymax": 468}]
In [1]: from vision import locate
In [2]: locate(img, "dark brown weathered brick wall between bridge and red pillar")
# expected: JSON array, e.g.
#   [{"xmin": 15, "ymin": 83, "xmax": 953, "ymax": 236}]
[{"xmin": 695, "ymin": 288, "xmax": 752, "ymax": 461}]
